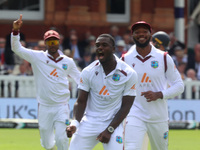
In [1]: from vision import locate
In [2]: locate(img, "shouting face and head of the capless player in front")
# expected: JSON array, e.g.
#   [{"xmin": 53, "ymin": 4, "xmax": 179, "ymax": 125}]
[{"xmin": 95, "ymin": 37, "xmax": 115, "ymax": 63}]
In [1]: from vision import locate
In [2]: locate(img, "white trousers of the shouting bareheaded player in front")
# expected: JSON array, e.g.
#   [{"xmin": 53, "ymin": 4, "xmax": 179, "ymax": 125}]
[{"xmin": 69, "ymin": 116, "xmax": 123, "ymax": 150}]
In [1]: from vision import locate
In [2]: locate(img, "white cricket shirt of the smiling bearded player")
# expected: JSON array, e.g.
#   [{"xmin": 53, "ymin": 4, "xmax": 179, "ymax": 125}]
[{"xmin": 122, "ymin": 45, "xmax": 184, "ymax": 122}]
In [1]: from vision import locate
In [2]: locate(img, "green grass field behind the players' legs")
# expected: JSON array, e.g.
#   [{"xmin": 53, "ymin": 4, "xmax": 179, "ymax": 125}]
[{"xmin": 0, "ymin": 129, "xmax": 200, "ymax": 150}]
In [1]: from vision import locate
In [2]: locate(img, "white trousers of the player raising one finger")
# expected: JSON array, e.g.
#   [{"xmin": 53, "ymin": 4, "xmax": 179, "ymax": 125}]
[{"xmin": 38, "ymin": 104, "xmax": 70, "ymax": 150}]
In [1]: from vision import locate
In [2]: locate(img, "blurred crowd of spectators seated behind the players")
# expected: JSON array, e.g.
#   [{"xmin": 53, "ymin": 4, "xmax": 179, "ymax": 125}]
[{"xmin": 0, "ymin": 25, "xmax": 200, "ymax": 98}]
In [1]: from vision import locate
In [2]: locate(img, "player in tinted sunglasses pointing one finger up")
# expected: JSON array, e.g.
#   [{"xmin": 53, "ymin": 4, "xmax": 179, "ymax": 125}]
[{"xmin": 11, "ymin": 15, "xmax": 80, "ymax": 150}]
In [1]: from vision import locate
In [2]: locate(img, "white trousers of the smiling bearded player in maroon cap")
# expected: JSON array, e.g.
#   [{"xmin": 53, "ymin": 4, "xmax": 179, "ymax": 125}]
[{"xmin": 124, "ymin": 116, "xmax": 169, "ymax": 150}]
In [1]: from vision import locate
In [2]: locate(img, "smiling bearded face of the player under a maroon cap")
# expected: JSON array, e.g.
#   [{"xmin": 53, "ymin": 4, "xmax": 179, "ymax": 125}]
[{"xmin": 133, "ymin": 26, "xmax": 151, "ymax": 48}]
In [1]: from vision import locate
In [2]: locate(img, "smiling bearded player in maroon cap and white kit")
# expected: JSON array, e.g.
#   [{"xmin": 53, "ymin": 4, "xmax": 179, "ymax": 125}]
[{"xmin": 122, "ymin": 21, "xmax": 184, "ymax": 150}]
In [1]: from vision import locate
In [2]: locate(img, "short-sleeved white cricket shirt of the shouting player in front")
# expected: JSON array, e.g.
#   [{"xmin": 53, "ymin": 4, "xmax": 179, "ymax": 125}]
[{"xmin": 78, "ymin": 57, "xmax": 137, "ymax": 121}]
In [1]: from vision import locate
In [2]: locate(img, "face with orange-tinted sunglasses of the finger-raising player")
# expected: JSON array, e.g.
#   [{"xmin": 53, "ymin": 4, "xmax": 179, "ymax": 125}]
[{"xmin": 45, "ymin": 37, "xmax": 59, "ymax": 55}]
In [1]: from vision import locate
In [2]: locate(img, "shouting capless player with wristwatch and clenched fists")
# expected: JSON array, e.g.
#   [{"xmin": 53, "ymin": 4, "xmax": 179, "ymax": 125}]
[{"xmin": 67, "ymin": 34, "xmax": 137, "ymax": 150}]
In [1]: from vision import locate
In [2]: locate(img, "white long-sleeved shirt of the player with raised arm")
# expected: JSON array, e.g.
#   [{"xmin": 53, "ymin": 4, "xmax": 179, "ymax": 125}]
[{"xmin": 11, "ymin": 33, "xmax": 80, "ymax": 106}]
